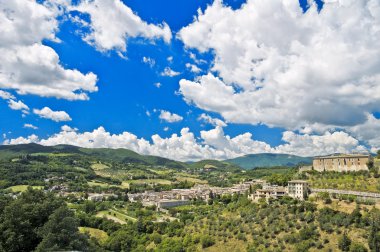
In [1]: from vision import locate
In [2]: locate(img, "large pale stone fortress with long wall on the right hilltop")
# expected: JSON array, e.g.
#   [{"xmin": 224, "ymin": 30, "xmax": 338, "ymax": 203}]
[{"xmin": 313, "ymin": 154, "xmax": 371, "ymax": 172}]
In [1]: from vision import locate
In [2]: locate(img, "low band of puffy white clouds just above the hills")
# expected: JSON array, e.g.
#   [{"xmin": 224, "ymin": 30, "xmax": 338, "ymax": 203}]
[{"xmin": 4, "ymin": 126, "xmax": 365, "ymax": 161}]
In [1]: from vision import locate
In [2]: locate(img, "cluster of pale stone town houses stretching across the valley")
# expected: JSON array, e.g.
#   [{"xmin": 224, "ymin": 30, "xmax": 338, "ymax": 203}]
[{"xmin": 128, "ymin": 180, "xmax": 309, "ymax": 210}]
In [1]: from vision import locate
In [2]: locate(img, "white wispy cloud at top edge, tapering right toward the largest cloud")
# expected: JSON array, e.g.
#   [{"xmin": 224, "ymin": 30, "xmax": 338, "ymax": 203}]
[{"xmin": 71, "ymin": 0, "xmax": 172, "ymax": 52}]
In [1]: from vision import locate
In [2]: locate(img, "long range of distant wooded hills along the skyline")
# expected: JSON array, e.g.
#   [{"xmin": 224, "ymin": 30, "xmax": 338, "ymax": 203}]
[{"xmin": 0, "ymin": 143, "xmax": 312, "ymax": 170}]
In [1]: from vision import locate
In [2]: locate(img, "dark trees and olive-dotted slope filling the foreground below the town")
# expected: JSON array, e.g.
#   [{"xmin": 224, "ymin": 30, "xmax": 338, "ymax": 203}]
[{"xmin": 0, "ymin": 189, "xmax": 380, "ymax": 252}]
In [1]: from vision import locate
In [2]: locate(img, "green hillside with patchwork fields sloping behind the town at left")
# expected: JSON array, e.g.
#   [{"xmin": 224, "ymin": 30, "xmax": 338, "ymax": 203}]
[{"xmin": 0, "ymin": 144, "xmax": 245, "ymax": 191}]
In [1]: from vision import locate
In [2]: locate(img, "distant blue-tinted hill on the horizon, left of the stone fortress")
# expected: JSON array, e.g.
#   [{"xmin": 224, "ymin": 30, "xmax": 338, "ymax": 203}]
[{"xmin": 225, "ymin": 153, "xmax": 312, "ymax": 169}]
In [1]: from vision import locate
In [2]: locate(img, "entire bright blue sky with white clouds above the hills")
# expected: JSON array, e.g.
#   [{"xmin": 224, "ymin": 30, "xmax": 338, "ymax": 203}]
[{"xmin": 0, "ymin": 0, "xmax": 380, "ymax": 161}]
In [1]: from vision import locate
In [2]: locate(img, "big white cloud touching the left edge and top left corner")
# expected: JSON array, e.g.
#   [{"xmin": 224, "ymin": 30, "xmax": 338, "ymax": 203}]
[{"xmin": 0, "ymin": 0, "xmax": 98, "ymax": 100}]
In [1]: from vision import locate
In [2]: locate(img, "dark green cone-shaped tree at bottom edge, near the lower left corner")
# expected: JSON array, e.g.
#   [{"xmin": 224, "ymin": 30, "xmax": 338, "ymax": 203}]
[{"xmin": 36, "ymin": 206, "xmax": 88, "ymax": 252}]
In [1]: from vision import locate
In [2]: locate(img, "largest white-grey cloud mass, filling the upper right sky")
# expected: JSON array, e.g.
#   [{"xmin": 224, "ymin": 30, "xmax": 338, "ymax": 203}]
[{"xmin": 177, "ymin": 0, "xmax": 380, "ymax": 130}]
